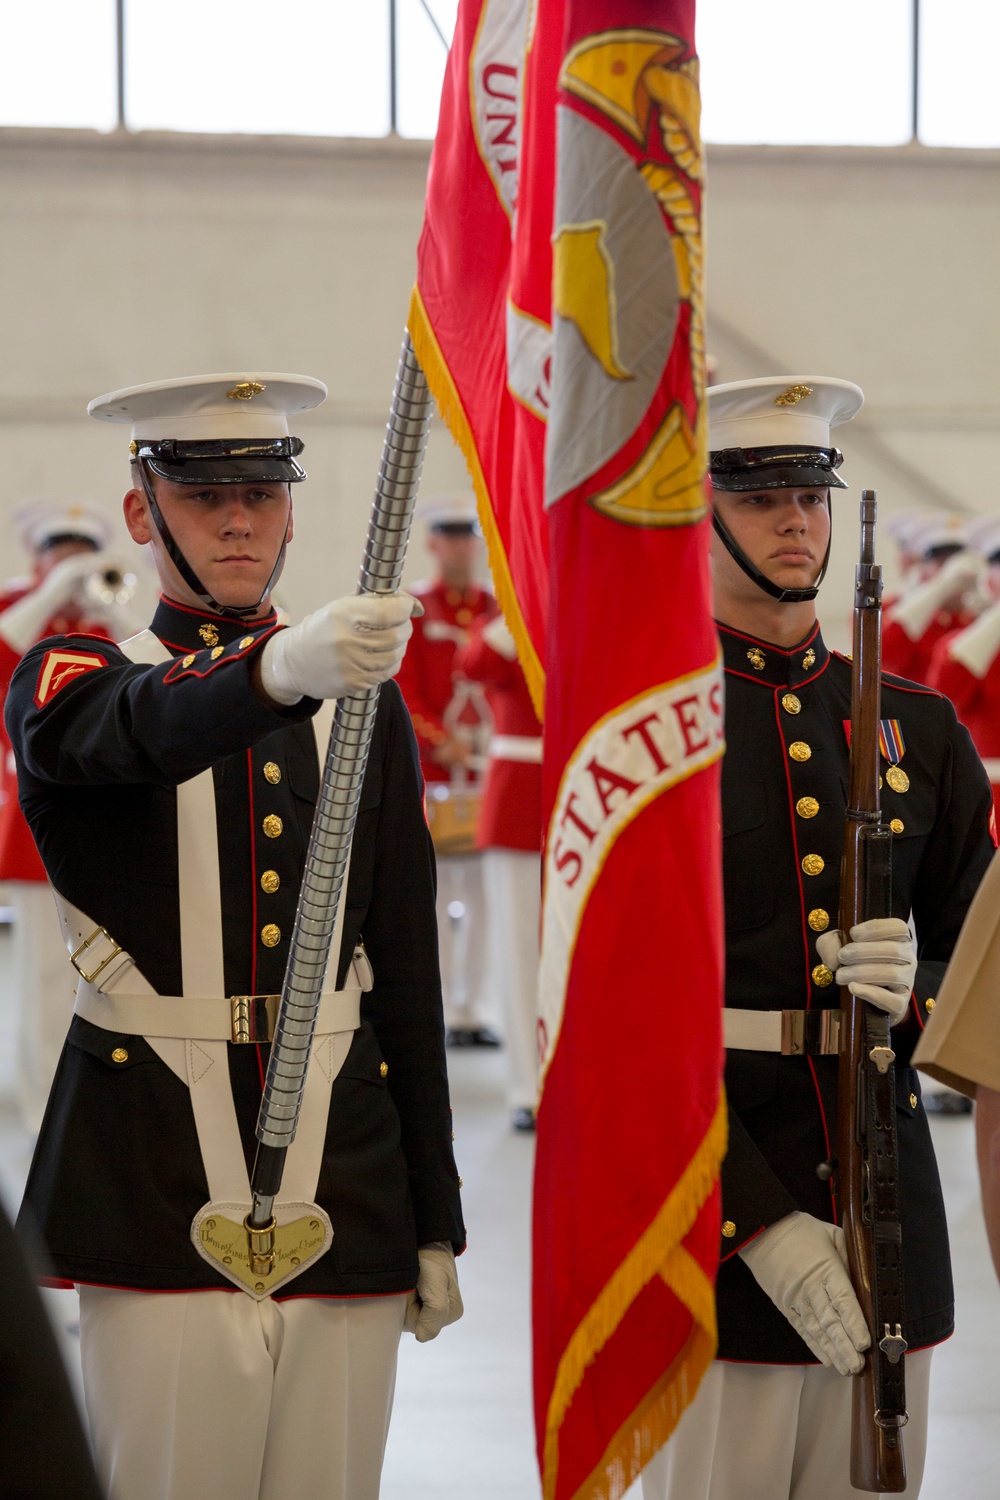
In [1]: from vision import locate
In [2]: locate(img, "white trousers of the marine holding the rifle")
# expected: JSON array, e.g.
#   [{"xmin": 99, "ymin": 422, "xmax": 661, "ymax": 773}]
[{"xmin": 642, "ymin": 1349, "xmax": 931, "ymax": 1500}]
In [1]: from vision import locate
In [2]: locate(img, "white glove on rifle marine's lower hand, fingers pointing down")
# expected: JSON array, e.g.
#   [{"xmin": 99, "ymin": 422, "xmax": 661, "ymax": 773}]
[{"xmin": 738, "ymin": 1212, "xmax": 871, "ymax": 1376}]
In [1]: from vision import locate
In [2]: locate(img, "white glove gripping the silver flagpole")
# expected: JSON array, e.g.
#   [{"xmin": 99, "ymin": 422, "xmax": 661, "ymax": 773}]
[{"xmin": 261, "ymin": 594, "xmax": 423, "ymax": 707}]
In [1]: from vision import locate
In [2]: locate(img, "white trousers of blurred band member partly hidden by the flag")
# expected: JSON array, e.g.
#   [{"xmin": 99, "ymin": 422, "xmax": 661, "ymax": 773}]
[{"xmin": 483, "ymin": 849, "xmax": 541, "ymax": 1110}]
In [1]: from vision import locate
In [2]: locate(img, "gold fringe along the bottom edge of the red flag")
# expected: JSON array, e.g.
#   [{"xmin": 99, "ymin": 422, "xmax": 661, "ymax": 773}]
[{"xmin": 543, "ymin": 1095, "xmax": 727, "ymax": 1500}]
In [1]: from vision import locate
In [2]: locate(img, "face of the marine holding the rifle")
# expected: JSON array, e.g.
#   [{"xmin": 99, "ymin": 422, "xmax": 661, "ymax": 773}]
[{"xmin": 712, "ymin": 488, "xmax": 831, "ymax": 588}]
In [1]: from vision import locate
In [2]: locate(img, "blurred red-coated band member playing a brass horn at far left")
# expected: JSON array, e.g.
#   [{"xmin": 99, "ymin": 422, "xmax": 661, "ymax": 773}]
[{"xmin": 0, "ymin": 503, "xmax": 133, "ymax": 1131}]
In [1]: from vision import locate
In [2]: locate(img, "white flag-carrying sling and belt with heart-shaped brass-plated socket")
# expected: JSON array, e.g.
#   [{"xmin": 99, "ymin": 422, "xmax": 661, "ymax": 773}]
[{"xmin": 55, "ymin": 630, "xmax": 361, "ymax": 1299}]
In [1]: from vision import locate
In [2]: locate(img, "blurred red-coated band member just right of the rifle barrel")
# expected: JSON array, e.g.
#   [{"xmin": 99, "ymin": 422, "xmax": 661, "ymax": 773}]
[{"xmin": 883, "ymin": 512, "xmax": 982, "ymax": 683}]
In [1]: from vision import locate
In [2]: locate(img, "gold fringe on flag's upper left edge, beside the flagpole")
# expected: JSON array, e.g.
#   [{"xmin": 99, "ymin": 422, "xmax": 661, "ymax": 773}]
[{"xmin": 406, "ymin": 287, "xmax": 546, "ymax": 719}]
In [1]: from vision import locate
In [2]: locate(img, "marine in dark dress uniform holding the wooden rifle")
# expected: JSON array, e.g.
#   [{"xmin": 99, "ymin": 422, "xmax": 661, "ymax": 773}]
[{"xmin": 643, "ymin": 377, "xmax": 993, "ymax": 1500}]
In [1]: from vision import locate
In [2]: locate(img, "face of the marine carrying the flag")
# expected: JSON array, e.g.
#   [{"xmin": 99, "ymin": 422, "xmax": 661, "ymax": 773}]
[{"xmin": 124, "ymin": 477, "xmax": 292, "ymax": 611}]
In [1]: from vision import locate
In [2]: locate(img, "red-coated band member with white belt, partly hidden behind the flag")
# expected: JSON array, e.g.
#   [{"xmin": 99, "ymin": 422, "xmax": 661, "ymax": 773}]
[{"xmin": 454, "ymin": 615, "xmax": 541, "ymax": 1131}]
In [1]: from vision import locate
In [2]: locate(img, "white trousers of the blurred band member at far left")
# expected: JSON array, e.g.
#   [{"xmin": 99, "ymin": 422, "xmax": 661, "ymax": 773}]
[{"xmin": 7, "ymin": 881, "xmax": 76, "ymax": 1134}]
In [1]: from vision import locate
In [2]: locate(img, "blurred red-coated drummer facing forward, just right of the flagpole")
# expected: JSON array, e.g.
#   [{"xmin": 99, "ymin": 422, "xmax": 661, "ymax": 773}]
[{"xmin": 397, "ymin": 495, "xmax": 499, "ymax": 1047}]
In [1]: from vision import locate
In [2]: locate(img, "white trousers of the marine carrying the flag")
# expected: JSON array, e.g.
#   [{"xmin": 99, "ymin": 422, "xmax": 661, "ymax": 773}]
[{"xmin": 79, "ymin": 1287, "xmax": 406, "ymax": 1500}]
